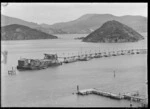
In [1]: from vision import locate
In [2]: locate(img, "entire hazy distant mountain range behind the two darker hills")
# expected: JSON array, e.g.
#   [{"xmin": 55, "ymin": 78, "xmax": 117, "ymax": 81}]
[{"xmin": 1, "ymin": 14, "xmax": 147, "ymax": 34}]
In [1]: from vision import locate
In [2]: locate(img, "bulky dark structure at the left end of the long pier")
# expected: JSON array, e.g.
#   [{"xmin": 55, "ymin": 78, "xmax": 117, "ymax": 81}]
[{"xmin": 17, "ymin": 54, "xmax": 62, "ymax": 70}]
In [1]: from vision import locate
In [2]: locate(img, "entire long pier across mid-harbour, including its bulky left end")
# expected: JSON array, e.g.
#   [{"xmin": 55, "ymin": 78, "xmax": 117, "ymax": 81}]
[{"xmin": 17, "ymin": 49, "xmax": 147, "ymax": 70}]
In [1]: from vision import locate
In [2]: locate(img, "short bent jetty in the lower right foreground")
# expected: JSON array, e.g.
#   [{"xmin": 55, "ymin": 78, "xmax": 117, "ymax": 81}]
[{"xmin": 76, "ymin": 88, "xmax": 146, "ymax": 102}]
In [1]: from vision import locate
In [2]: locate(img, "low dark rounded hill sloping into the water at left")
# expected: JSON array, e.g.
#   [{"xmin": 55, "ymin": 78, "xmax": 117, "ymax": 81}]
[{"xmin": 1, "ymin": 24, "xmax": 57, "ymax": 40}]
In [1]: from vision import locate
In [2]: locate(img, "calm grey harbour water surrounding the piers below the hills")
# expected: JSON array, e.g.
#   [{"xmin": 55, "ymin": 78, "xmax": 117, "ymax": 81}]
[{"xmin": 1, "ymin": 34, "xmax": 147, "ymax": 107}]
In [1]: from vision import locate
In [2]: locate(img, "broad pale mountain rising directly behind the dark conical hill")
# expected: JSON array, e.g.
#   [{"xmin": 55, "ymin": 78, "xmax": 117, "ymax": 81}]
[{"xmin": 50, "ymin": 14, "xmax": 147, "ymax": 34}]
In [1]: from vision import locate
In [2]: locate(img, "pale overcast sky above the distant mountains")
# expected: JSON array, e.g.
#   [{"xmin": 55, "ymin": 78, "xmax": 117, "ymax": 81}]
[{"xmin": 1, "ymin": 3, "xmax": 148, "ymax": 24}]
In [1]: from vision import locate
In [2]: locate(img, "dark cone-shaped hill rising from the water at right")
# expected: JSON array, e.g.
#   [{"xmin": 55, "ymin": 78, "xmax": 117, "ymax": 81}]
[{"xmin": 83, "ymin": 20, "xmax": 144, "ymax": 43}]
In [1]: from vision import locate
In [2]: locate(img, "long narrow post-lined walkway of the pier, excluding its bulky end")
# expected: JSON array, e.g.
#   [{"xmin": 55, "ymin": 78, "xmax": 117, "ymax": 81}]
[{"xmin": 58, "ymin": 49, "xmax": 147, "ymax": 63}]
